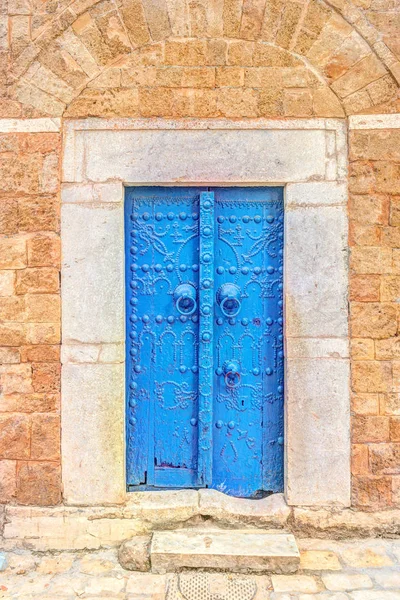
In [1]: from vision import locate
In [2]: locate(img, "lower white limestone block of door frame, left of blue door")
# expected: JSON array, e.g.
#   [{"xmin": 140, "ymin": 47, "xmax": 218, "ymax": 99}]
[{"xmin": 61, "ymin": 363, "xmax": 125, "ymax": 504}]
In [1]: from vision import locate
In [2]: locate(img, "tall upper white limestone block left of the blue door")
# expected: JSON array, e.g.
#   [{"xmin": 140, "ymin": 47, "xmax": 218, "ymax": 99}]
[{"xmin": 61, "ymin": 204, "xmax": 124, "ymax": 343}]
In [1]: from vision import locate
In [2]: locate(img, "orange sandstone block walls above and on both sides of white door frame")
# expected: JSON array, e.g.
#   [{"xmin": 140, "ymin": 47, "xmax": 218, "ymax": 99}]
[{"xmin": 0, "ymin": 0, "xmax": 400, "ymax": 510}]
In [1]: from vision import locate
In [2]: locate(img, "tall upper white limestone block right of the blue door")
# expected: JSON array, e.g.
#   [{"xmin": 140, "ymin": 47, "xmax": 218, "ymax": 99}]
[{"xmin": 285, "ymin": 206, "xmax": 348, "ymax": 337}]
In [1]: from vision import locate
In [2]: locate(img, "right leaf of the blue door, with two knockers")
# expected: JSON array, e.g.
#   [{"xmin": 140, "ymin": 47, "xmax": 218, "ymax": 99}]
[{"xmin": 213, "ymin": 188, "xmax": 283, "ymax": 497}]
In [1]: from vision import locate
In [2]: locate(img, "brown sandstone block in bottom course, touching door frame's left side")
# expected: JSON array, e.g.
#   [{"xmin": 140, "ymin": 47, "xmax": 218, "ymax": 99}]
[{"xmin": 16, "ymin": 461, "xmax": 61, "ymax": 506}]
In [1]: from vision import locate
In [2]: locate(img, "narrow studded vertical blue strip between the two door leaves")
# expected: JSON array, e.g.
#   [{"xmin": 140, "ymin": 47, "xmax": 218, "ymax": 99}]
[{"xmin": 198, "ymin": 192, "xmax": 214, "ymax": 486}]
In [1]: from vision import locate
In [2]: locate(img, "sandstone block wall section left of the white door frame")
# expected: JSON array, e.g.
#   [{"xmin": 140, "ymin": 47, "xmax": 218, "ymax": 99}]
[{"xmin": 0, "ymin": 126, "xmax": 61, "ymax": 505}]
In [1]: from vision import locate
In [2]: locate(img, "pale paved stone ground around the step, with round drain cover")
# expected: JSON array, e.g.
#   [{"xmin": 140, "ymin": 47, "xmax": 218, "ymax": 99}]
[{"xmin": 0, "ymin": 539, "xmax": 400, "ymax": 600}]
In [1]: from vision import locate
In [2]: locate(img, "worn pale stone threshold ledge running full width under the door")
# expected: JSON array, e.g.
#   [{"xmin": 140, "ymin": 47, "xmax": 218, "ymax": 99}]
[{"xmin": 0, "ymin": 490, "xmax": 400, "ymax": 551}]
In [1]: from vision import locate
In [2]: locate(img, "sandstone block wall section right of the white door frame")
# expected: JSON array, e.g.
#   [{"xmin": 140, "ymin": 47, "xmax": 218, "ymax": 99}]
[{"xmin": 349, "ymin": 117, "xmax": 400, "ymax": 510}]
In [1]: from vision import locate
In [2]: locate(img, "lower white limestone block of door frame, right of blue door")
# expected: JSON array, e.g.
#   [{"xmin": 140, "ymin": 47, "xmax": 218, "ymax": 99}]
[{"xmin": 286, "ymin": 358, "xmax": 350, "ymax": 506}]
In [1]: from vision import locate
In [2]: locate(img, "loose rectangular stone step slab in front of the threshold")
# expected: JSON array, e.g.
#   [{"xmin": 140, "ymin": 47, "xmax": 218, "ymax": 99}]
[{"xmin": 150, "ymin": 529, "xmax": 300, "ymax": 574}]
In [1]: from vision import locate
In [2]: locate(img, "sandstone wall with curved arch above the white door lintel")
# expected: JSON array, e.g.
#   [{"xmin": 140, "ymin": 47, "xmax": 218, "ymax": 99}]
[{"xmin": 0, "ymin": 0, "xmax": 400, "ymax": 118}]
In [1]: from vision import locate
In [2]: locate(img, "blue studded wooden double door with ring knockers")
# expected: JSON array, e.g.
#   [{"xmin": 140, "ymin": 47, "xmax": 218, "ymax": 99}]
[{"xmin": 126, "ymin": 187, "xmax": 283, "ymax": 497}]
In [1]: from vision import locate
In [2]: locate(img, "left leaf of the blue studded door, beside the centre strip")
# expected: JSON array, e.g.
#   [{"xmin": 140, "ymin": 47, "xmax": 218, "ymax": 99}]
[{"xmin": 126, "ymin": 188, "xmax": 205, "ymax": 487}]
